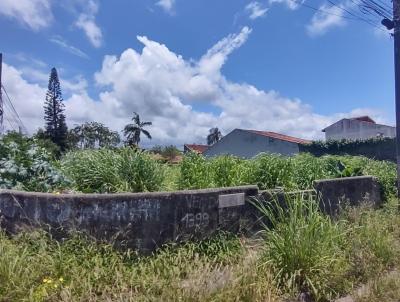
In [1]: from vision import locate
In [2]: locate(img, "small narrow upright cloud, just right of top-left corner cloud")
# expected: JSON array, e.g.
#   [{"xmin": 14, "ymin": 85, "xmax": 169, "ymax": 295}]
[{"xmin": 75, "ymin": 0, "xmax": 103, "ymax": 48}]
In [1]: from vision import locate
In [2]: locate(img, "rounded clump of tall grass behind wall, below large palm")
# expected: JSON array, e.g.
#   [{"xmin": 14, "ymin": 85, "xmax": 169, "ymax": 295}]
[{"xmin": 62, "ymin": 148, "xmax": 164, "ymax": 193}]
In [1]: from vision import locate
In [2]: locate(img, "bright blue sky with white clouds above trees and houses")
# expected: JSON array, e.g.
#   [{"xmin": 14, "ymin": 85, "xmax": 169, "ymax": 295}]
[{"xmin": 0, "ymin": 0, "xmax": 394, "ymax": 144}]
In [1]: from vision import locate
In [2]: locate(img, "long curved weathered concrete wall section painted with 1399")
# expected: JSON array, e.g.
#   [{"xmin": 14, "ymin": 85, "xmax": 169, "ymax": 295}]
[{"xmin": 0, "ymin": 186, "xmax": 258, "ymax": 253}]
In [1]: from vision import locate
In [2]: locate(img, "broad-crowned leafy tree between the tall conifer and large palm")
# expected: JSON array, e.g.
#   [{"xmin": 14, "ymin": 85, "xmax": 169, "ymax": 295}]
[{"xmin": 68, "ymin": 122, "xmax": 121, "ymax": 149}]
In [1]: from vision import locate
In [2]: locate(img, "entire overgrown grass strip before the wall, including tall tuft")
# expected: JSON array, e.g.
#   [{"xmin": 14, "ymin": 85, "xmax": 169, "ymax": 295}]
[{"xmin": 0, "ymin": 197, "xmax": 400, "ymax": 302}]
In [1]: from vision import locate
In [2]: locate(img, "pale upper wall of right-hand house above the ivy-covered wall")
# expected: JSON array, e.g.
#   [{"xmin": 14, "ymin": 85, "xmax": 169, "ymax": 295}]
[{"xmin": 325, "ymin": 119, "xmax": 396, "ymax": 140}]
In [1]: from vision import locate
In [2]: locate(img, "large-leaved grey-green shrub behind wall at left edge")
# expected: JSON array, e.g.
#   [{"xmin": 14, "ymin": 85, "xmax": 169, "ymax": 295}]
[{"xmin": 0, "ymin": 133, "xmax": 68, "ymax": 192}]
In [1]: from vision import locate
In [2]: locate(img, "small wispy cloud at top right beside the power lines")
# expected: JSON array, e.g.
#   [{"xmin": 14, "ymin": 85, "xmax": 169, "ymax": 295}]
[{"xmin": 306, "ymin": 4, "xmax": 346, "ymax": 36}]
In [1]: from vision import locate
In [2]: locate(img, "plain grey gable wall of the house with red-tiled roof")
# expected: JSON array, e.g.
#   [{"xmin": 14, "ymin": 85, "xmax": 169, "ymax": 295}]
[{"xmin": 203, "ymin": 129, "xmax": 299, "ymax": 158}]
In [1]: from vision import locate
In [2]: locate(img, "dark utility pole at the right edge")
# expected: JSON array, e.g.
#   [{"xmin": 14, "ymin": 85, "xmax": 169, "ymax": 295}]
[{"xmin": 393, "ymin": 0, "xmax": 400, "ymax": 203}]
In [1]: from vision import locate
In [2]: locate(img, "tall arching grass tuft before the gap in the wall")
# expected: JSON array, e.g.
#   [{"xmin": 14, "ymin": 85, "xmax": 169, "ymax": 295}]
[{"xmin": 254, "ymin": 195, "xmax": 347, "ymax": 300}]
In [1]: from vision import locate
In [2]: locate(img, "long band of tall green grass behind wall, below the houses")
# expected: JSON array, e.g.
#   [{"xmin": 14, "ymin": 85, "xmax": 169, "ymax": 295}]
[{"xmin": 176, "ymin": 153, "xmax": 397, "ymax": 200}]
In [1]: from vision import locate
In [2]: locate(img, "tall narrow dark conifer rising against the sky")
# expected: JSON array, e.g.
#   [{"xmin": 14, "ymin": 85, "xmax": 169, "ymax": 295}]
[{"xmin": 44, "ymin": 68, "xmax": 68, "ymax": 151}]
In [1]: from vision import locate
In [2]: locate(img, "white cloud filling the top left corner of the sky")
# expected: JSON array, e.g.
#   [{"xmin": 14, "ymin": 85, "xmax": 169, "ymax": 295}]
[{"xmin": 0, "ymin": 0, "xmax": 53, "ymax": 31}]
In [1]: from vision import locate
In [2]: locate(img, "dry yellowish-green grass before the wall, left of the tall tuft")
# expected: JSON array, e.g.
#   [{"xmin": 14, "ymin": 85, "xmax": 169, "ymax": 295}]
[{"xmin": 0, "ymin": 233, "xmax": 277, "ymax": 302}]
